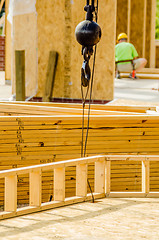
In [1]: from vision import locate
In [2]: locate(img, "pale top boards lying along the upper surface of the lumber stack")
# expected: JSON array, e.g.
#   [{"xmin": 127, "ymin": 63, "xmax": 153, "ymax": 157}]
[{"xmin": 0, "ymin": 101, "xmax": 156, "ymax": 116}]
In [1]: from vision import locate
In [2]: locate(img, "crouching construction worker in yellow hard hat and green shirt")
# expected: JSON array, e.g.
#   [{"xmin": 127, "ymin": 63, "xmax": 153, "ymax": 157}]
[{"xmin": 115, "ymin": 33, "xmax": 147, "ymax": 78}]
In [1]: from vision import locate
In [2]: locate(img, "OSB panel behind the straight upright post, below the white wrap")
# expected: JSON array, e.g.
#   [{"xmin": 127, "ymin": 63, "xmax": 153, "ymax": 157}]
[{"xmin": 12, "ymin": 13, "xmax": 37, "ymax": 97}]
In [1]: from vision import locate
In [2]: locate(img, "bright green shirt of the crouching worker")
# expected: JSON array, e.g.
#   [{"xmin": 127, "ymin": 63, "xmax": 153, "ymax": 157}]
[{"xmin": 115, "ymin": 42, "xmax": 138, "ymax": 64}]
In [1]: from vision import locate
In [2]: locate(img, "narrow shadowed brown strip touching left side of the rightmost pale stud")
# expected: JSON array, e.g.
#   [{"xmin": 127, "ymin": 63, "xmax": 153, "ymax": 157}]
[{"xmin": 145, "ymin": 0, "xmax": 152, "ymax": 67}]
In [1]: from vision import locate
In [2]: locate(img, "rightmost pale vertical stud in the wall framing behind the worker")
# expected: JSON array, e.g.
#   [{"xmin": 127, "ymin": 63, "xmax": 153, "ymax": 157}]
[{"xmin": 150, "ymin": 0, "xmax": 156, "ymax": 68}]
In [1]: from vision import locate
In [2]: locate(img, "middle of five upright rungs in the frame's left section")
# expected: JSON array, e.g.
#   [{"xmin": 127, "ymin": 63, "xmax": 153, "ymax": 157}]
[{"xmin": 54, "ymin": 168, "xmax": 65, "ymax": 201}]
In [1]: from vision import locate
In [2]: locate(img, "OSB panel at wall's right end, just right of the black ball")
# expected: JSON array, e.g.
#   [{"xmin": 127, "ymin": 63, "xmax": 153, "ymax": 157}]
[{"xmin": 93, "ymin": 0, "xmax": 116, "ymax": 100}]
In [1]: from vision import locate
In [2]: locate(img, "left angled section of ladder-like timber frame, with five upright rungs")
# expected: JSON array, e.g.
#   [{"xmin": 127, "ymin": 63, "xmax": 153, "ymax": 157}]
[{"xmin": 0, "ymin": 156, "xmax": 105, "ymax": 220}]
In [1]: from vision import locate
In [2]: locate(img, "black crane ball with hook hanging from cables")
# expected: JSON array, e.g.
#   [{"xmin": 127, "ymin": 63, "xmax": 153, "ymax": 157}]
[{"xmin": 75, "ymin": 0, "xmax": 101, "ymax": 87}]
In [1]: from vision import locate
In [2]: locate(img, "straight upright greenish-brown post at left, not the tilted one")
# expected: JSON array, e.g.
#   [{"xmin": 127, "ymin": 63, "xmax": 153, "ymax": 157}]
[{"xmin": 15, "ymin": 50, "xmax": 25, "ymax": 101}]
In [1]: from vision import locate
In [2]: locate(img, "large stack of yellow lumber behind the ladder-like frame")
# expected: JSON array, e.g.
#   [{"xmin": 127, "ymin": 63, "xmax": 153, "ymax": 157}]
[{"xmin": 0, "ymin": 102, "xmax": 159, "ymax": 205}]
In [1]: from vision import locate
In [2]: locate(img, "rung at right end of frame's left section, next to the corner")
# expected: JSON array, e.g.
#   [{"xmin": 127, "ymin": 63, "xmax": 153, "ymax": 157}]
[{"xmin": 95, "ymin": 159, "xmax": 105, "ymax": 193}]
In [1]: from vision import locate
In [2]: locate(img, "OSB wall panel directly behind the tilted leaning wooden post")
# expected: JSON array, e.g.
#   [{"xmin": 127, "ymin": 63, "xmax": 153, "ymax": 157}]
[{"xmin": 36, "ymin": 0, "xmax": 65, "ymax": 97}]
